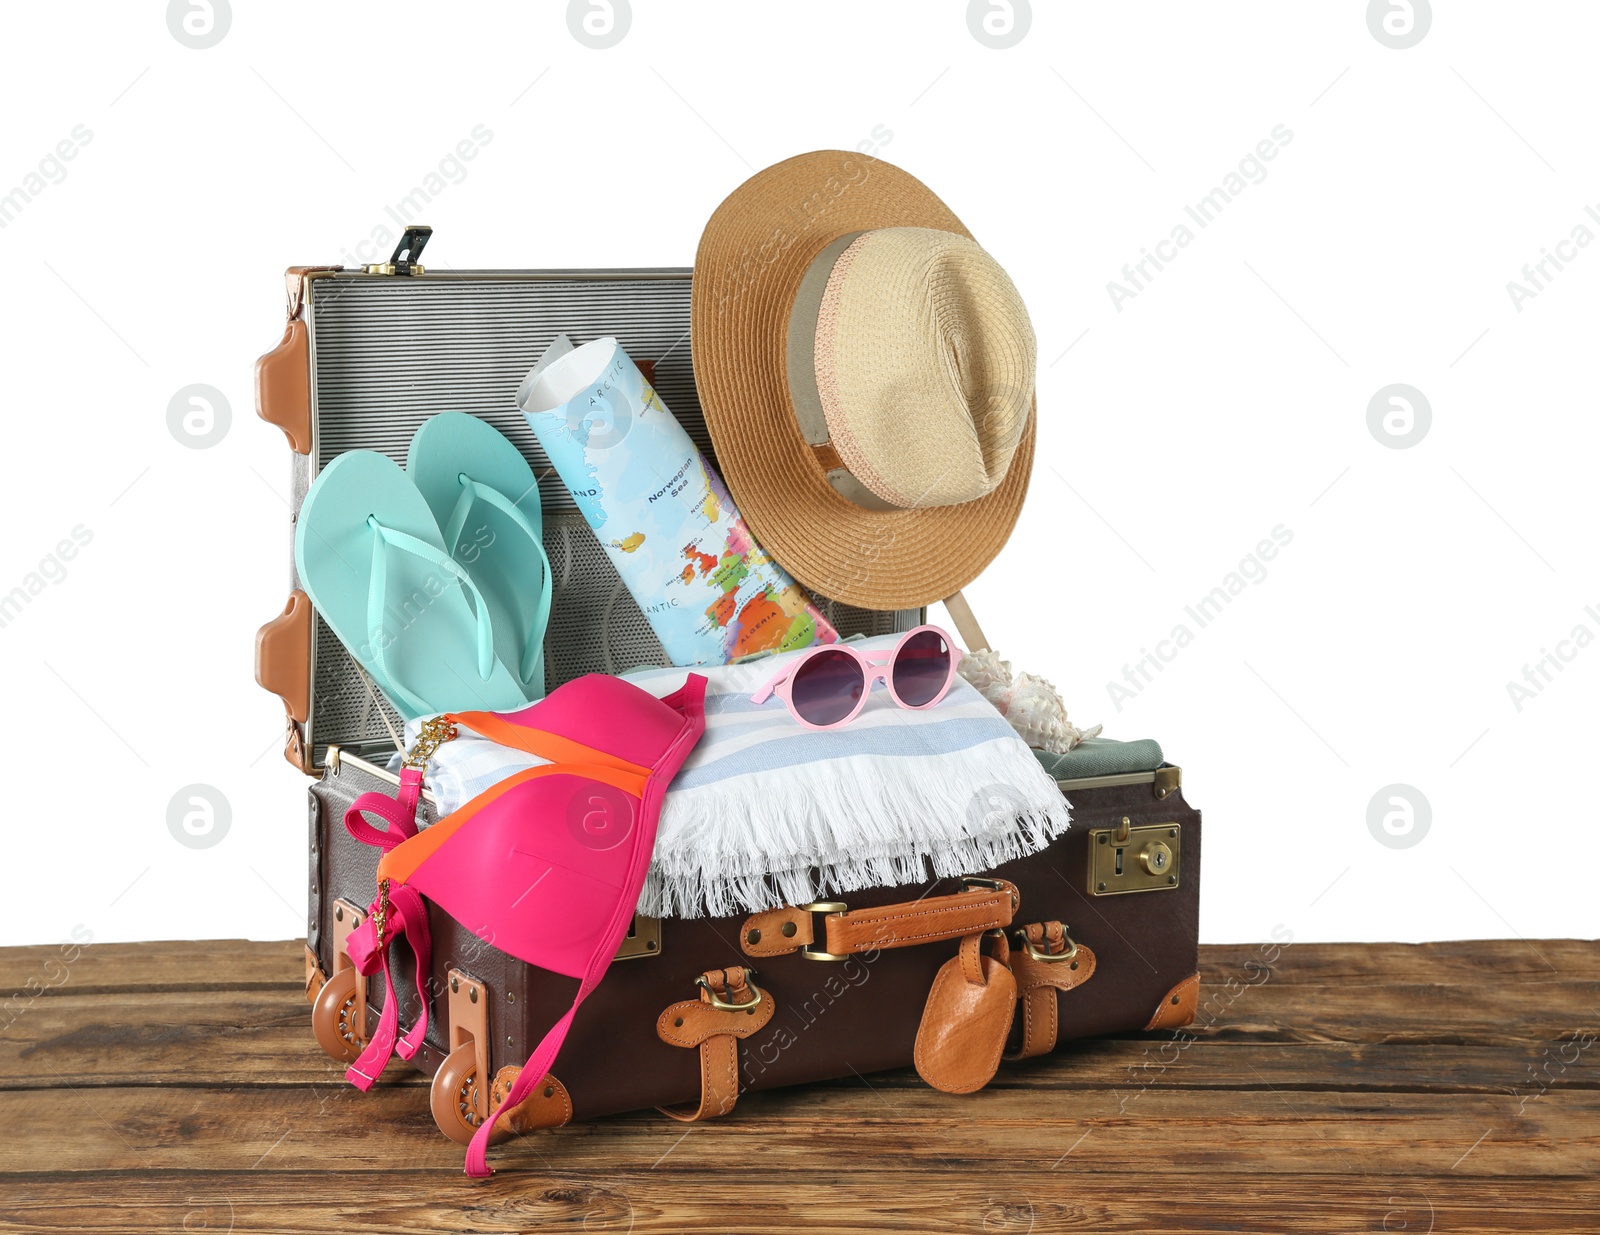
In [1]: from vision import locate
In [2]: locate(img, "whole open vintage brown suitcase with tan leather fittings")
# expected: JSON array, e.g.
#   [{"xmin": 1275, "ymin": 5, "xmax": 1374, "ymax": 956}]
[{"xmin": 258, "ymin": 238, "xmax": 1200, "ymax": 1141}]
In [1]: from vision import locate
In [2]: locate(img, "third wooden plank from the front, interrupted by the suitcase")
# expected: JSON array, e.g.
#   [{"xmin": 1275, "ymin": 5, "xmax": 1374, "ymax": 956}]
[{"xmin": 0, "ymin": 982, "xmax": 1600, "ymax": 1089}]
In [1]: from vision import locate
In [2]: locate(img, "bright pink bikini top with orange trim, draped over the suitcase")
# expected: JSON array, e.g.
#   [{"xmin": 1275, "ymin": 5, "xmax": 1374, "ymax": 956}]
[{"xmin": 344, "ymin": 673, "xmax": 706, "ymax": 1176}]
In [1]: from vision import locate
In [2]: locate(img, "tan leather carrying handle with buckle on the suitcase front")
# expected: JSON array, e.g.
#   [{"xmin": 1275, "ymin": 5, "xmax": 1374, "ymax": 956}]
[{"xmin": 739, "ymin": 880, "xmax": 1021, "ymax": 957}]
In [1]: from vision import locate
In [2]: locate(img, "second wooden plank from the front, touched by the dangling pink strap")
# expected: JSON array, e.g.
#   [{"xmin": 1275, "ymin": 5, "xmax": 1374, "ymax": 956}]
[{"xmin": 0, "ymin": 1086, "xmax": 1600, "ymax": 1189}]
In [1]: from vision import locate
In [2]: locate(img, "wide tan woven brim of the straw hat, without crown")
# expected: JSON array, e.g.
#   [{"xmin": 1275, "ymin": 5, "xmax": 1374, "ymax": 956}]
[{"xmin": 690, "ymin": 150, "xmax": 1037, "ymax": 610}]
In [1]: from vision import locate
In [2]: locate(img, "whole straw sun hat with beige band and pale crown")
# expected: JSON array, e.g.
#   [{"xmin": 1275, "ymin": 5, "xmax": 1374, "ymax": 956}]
[{"xmin": 691, "ymin": 150, "xmax": 1035, "ymax": 610}]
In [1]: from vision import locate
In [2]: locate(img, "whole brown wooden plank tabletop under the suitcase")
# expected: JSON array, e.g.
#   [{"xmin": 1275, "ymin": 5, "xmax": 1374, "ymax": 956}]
[{"xmin": 0, "ymin": 941, "xmax": 1600, "ymax": 1235}]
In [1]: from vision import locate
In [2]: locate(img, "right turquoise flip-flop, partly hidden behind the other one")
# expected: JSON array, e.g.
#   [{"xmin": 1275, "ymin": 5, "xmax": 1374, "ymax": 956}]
[{"xmin": 405, "ymin": 411, "xmax": 550, "ymax": 699}]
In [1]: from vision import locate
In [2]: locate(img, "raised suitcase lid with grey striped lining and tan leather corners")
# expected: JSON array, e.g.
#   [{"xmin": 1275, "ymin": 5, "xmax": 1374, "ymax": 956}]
[{"xmin": 256, "ymin": 243, "xmax": 923, "ymax": 773}]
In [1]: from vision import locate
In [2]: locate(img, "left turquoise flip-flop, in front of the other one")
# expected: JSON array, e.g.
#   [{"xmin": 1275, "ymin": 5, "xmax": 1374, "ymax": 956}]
[{"xmin": 294, "ymin": 450, "xmax": 533, "ymax": 720}]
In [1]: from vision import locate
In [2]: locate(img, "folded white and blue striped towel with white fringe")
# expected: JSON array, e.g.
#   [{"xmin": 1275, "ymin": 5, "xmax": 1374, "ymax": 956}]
[{"xmin": 406, "ymin": 635, "xmax": 1070, "ymax": 918}]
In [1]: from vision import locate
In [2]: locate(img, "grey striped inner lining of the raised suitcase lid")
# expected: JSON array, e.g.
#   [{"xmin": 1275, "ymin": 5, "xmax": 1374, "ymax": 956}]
[{"xmin": 296, "ymin": 270, "xmax": 920, "ymax": 763}]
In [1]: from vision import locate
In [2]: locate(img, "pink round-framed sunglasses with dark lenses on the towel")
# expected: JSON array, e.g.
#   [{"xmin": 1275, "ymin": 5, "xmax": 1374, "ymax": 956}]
[{"xmin": 750, "ymin": 625, "xmax": 962, "ymax": 729}]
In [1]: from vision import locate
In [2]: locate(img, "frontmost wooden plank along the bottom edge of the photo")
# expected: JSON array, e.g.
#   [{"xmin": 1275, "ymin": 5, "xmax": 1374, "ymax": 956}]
[{"xmin": 0, "ymin": 1160, "xmax": 1600, "ymax": 1235}]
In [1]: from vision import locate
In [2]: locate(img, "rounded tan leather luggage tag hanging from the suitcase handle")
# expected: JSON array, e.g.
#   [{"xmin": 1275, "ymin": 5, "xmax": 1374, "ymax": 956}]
[{"xmin": 914, "ymin": 936, "xmax": 1016, "ymax": 1094}]
